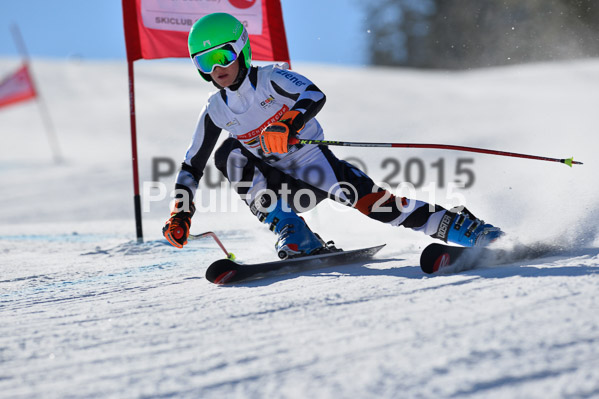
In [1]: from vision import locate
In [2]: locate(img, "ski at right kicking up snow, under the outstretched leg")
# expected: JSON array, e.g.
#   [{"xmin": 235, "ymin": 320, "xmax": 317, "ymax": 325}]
[{"xmin": 420, "ymin": 243, "xmax": 561, "ymax": 274}]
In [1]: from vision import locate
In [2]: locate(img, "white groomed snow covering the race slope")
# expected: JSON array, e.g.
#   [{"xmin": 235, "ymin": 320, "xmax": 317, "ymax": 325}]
[{"xmin": 0, "ymin": 59, "xmax": 599, "ymax": 398}]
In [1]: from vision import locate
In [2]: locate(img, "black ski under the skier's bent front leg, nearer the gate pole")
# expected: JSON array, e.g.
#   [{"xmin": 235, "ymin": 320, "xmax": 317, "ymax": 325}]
[{"xmin": 206, "ymin": 244, "xmax": 385, "ymax": 285}]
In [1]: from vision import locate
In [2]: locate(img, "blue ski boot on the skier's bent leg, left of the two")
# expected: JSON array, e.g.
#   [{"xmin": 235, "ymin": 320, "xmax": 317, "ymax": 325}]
[{"xmin": 258, "ymin": 199, "xmax": 330, "ymax": 259}]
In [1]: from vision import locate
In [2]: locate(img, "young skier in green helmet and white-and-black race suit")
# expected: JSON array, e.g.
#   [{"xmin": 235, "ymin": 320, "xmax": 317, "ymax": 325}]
[{"xmin": 163, "ymin": 13, "xmax": 502, "ymax": 258}]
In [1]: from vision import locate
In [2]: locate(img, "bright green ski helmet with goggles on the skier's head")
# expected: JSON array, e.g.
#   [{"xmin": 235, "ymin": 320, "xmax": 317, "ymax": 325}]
[{"xmin": 187, "ymin": 12, "xmax": 252, "ymax": 82}]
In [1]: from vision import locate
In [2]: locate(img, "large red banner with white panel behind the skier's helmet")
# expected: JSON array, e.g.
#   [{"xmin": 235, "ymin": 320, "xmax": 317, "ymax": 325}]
[{"xmin": 122, "ymin": 0, "xmax": 289, "ymax": 62}]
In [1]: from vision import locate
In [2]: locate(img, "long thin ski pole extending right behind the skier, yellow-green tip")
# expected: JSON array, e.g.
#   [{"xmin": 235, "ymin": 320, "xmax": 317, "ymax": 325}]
[{"xmin": 289, "ymin": 138, "xmax": 583, "ymax": 167}]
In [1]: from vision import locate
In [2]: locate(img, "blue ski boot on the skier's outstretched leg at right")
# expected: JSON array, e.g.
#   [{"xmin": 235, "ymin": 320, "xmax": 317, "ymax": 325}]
[{"xmin": 432, "ymin": 208, "xmax": 504, "ymax": 247}]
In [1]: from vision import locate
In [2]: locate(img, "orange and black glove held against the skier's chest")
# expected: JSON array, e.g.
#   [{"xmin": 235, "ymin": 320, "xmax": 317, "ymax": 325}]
[{"xmin": 260, "ymin": 111, "xmax": 304, "ymax": 154}]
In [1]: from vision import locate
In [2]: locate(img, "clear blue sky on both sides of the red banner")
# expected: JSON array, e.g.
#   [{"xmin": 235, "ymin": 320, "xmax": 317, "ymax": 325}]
[{"xmin": 0, "ymin": 0, "xmax": 368, "ymax": 65}]
